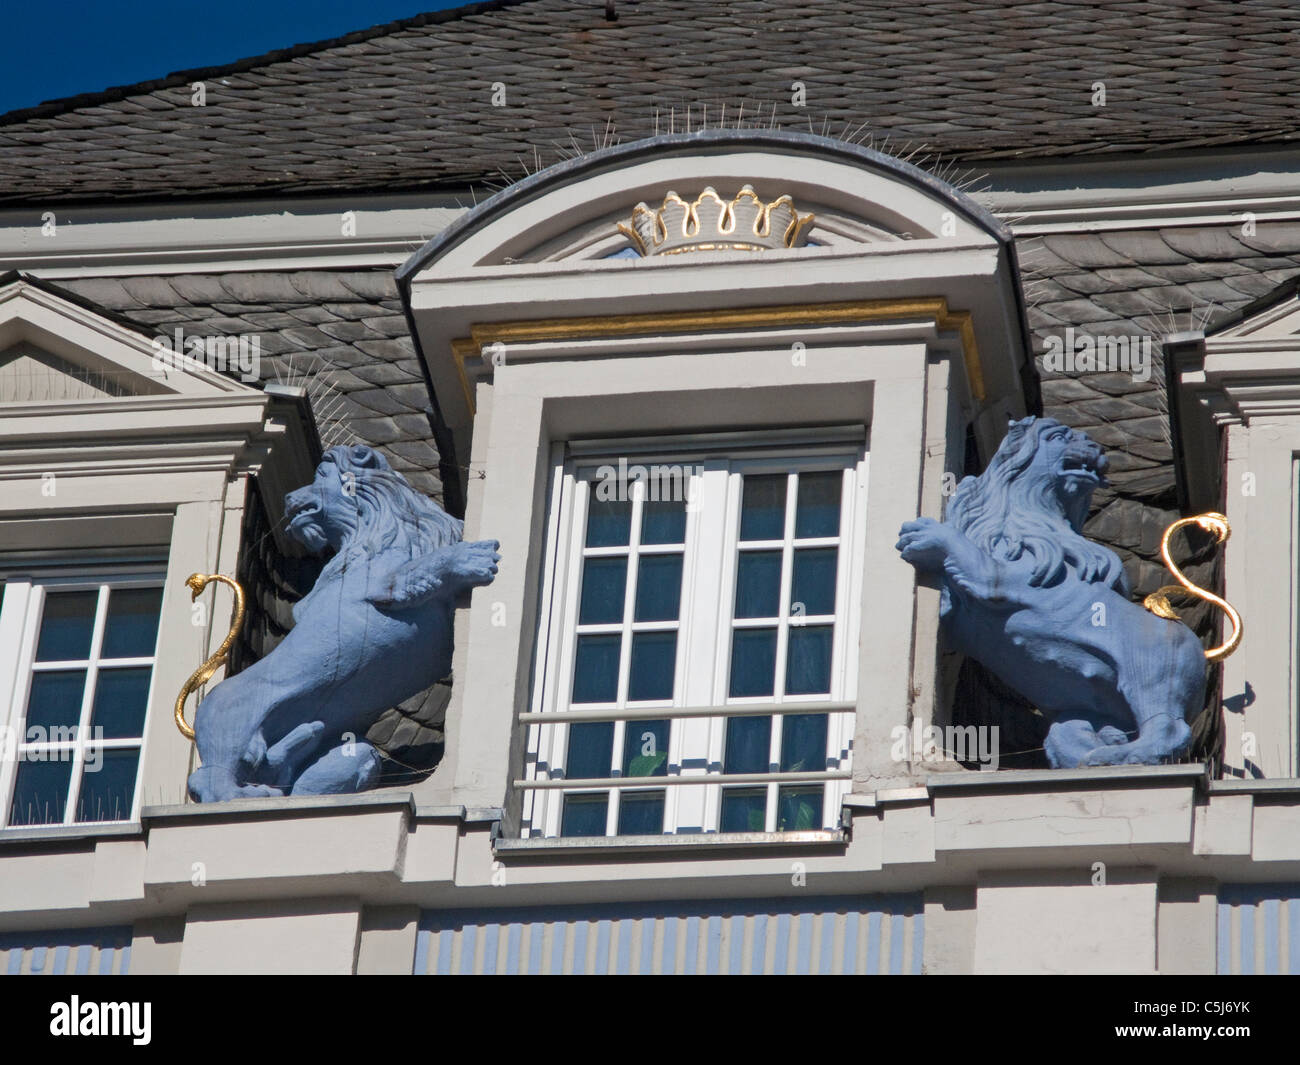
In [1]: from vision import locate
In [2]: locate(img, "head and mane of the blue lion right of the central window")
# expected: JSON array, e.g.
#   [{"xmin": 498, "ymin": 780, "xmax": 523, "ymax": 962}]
[{"xmin": 945, "ymin": 417, "xmax": 1127, "ymax": 590}]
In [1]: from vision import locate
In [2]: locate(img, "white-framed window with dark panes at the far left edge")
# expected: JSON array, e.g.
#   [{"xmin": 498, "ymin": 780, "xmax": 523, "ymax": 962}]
[{"xmin": 0, "ymin": 575, "xmax": 163, "ymax": 828}]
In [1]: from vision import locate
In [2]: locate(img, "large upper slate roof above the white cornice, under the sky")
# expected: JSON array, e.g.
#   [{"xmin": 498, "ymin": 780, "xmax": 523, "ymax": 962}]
[{"xmin": 0, "ymin": 0, "xmax": 1300, "ymax": 204}]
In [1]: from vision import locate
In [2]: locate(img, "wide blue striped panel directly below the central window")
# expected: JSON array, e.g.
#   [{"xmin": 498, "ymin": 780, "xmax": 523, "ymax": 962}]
[{"xmin": 415, "ymin": 895, "xmax": 924, "ymax": 975}]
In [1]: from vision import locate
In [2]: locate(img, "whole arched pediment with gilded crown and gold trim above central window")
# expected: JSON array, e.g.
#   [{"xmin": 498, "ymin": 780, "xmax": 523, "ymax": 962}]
[{"xmin": 397, "ymin": 130, "xmax": 1037, "ymax": 496}]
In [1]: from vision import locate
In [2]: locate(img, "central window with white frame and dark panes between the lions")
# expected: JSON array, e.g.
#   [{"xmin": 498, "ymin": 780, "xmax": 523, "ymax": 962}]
[{"xmin": 521, "ymin": 436, "xmax": 866, "ymax": 837}]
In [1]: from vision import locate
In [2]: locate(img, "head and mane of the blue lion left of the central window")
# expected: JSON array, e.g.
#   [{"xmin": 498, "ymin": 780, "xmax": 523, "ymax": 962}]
[{"xmin": 285, "ymin": 445, "xmax": 463, "ymax": 566}]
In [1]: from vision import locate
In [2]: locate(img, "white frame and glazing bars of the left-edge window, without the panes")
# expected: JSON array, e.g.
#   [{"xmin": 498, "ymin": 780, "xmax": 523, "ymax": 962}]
[{"xmin": 0, "ymin": 567, "xmax": 165, "ymax": 831}]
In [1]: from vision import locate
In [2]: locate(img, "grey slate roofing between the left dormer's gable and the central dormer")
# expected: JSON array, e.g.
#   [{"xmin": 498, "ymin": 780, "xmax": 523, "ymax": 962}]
[{"xmin": 56, "ymin": 269, "xmax": 442, "ymax": 499}]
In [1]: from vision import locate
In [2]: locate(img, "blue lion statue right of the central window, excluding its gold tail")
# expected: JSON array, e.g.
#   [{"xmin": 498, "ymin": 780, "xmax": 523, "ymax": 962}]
[{"xmin": 897, "ymin": 417, "xmax": 1205, "ymax": 767}]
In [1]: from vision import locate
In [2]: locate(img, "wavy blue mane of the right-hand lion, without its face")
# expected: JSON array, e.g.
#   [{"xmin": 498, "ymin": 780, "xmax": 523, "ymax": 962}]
[{"xmin": 945, "ymin": 417, "xmax": 1128, "ymax": 596}]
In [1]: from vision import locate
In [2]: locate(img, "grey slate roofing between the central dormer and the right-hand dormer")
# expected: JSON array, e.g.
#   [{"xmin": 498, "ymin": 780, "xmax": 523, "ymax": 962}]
[{"xmin": 1018, "ymin": 221, "xmax": 1300, "ymax": 611}]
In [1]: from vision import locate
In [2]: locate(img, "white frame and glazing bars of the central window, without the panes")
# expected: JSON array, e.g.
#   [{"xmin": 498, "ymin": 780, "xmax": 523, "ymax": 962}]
[{"xmin": 520, "ymin": 427, "xmax": 870, "ymax": 837}]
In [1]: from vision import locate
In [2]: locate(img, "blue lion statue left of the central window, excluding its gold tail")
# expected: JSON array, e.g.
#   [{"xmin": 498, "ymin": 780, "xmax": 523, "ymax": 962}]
[{"xmin": 189, "ymin": 446, "xmax": 501, "ymax": 802}]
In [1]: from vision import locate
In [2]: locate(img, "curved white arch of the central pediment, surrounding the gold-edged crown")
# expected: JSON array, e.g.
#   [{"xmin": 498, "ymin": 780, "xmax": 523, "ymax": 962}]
[{"xmin": 399, "ymin": 130, "xmax": 1006, "ymax": 278}]
